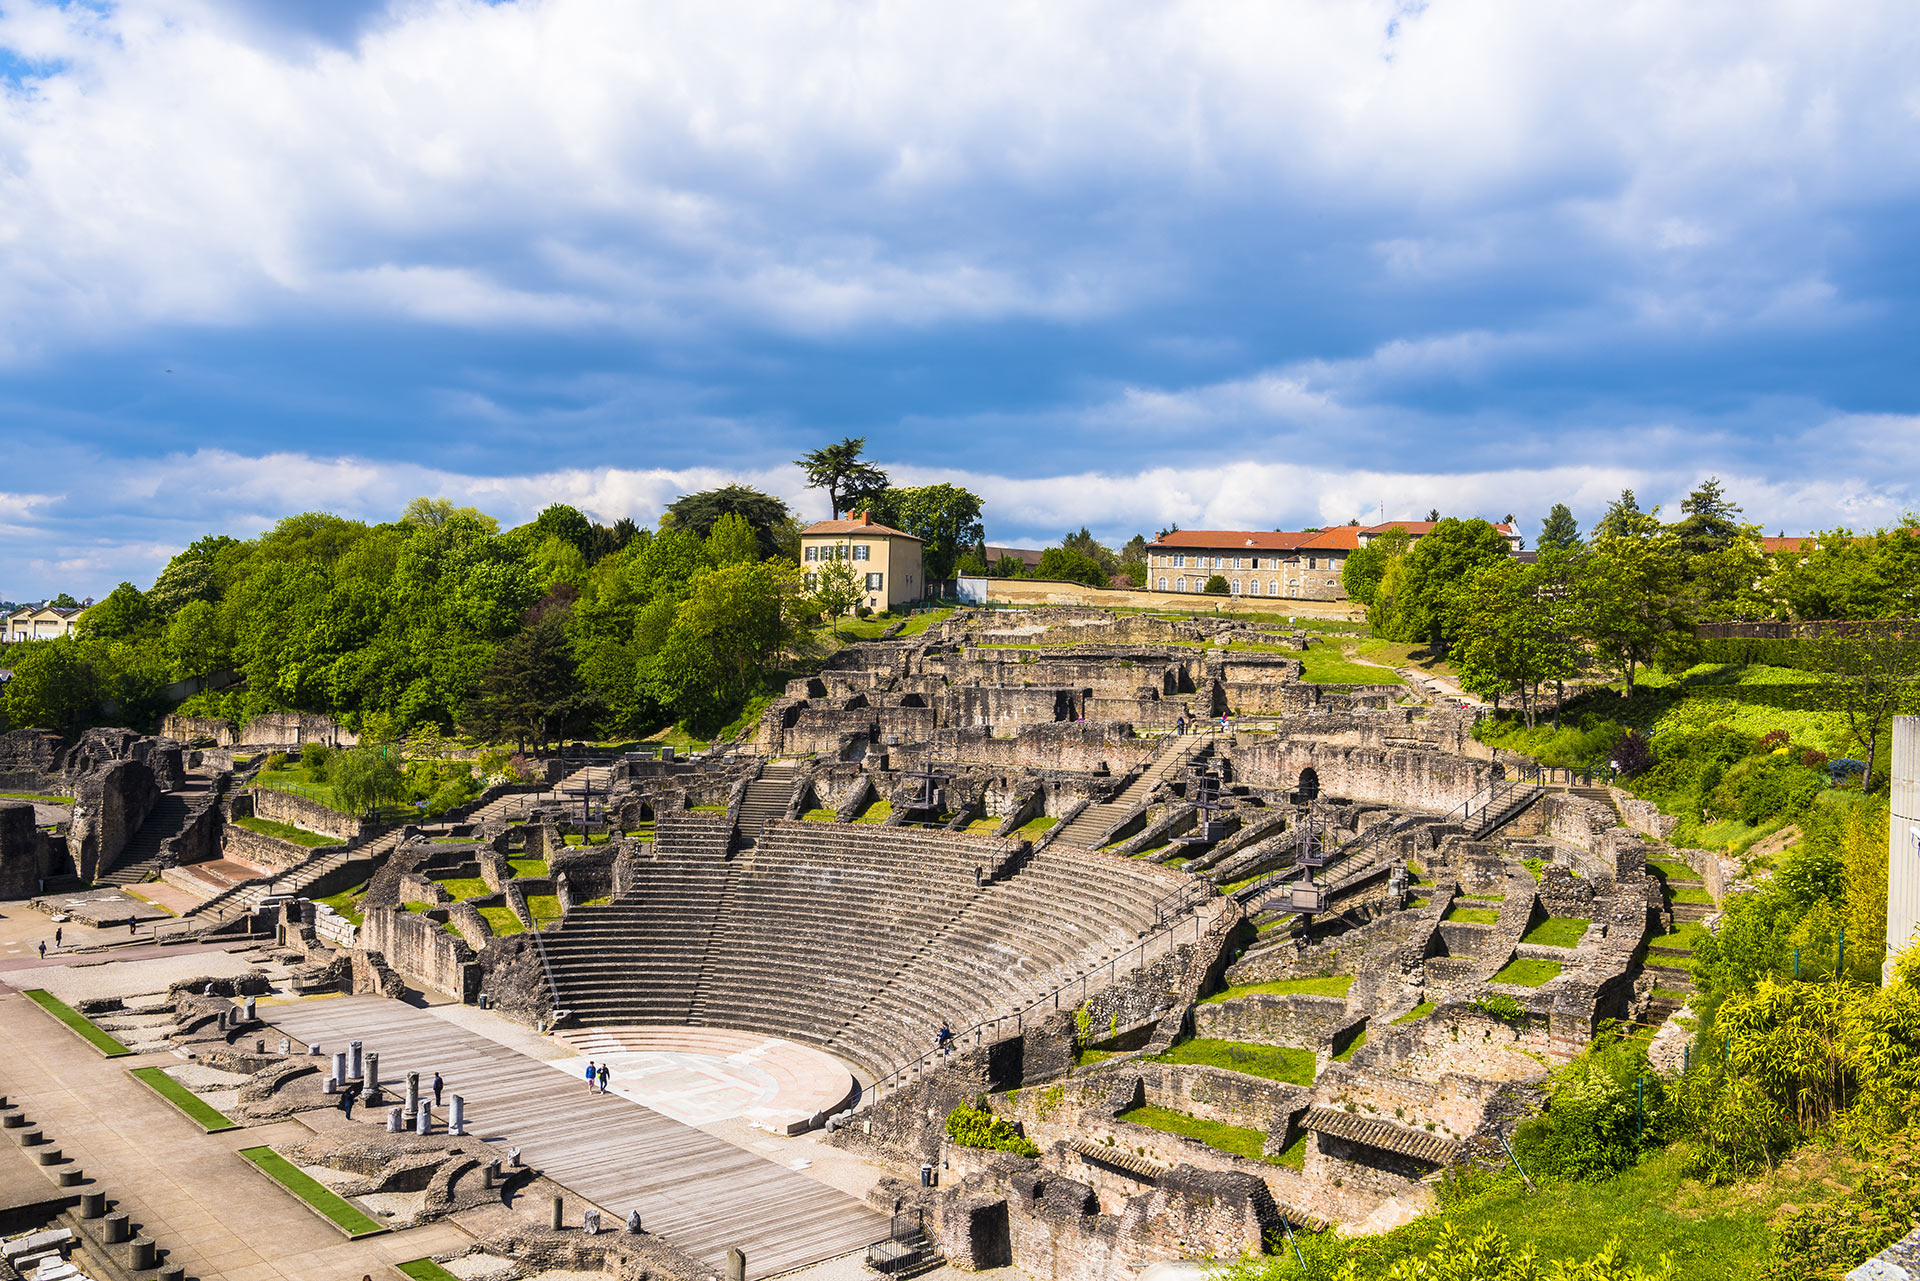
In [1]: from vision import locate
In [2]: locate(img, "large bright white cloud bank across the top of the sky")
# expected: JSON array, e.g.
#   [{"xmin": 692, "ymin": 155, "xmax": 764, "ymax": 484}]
[{"xmin": 0, "ymin": 0, "xmax": 1920, "ymax": 350}]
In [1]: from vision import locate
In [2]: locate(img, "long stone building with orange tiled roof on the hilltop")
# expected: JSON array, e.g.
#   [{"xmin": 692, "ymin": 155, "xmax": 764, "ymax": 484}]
[{"xmin": 1146, "ymin": 520, "xmax": 1521, "ymax": 601}]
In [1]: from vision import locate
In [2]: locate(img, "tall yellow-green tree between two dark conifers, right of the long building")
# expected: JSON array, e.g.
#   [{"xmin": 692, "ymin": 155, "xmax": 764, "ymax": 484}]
[{"xmin": 1578, "ymin": 510, "xmax": 1690, "ymax": 697}]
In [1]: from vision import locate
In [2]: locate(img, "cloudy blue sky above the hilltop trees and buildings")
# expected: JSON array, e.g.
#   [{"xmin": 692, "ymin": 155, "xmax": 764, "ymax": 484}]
[{"xmin": 0, "ymin": 0, "xmax": 1920, "ymax": 599}]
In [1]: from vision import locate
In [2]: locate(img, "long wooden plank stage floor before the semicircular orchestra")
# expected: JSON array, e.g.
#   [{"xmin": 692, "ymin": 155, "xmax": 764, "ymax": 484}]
[{"xmin": 261, "ymin": 997, "xmax": 887, "ymax": 1277}]
